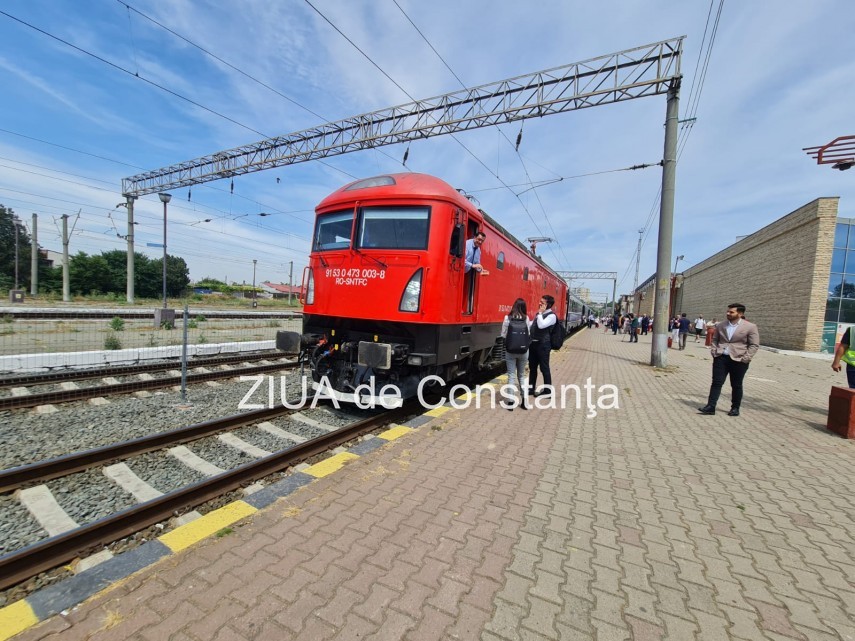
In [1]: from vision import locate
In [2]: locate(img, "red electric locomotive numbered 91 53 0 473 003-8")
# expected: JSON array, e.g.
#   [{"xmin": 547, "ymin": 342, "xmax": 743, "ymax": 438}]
[{"xmin": 277, "ymin": 173, "xmax": 570, "ymax": 402}]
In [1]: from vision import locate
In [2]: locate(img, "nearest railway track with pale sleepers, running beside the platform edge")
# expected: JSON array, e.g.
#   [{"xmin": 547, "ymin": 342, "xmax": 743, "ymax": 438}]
[{"xmin": 0, "ymin": 404, "xmax": 419, "ymax": 590}]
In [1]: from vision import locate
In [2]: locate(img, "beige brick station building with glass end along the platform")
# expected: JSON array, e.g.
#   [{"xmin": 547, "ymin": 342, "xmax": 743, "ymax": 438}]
[{"xmin": 631, "ymin": 197, "xmax": 844, "ymax": 353}]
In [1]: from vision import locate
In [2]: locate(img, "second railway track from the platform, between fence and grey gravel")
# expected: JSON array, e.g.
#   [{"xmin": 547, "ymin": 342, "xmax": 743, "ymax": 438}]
[{"xmin": 0, "ymin": 353, "xmax": 296, "ymax": 411}]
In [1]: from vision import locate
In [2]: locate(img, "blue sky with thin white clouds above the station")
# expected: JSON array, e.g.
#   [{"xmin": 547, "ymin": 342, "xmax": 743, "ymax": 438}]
[{"xmin": 0, "ymin": 0, "xmax": 855, "ymax": 301}]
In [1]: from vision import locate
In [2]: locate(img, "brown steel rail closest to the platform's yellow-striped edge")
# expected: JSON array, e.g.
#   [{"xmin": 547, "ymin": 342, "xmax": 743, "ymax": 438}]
[{"xmin": 0, "ymin": 403, "xmax": 420, "ymax": 590}]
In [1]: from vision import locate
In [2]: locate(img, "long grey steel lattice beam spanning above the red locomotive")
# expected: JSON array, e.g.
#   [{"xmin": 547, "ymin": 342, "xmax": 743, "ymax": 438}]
[{"xmin": 122, "ymin": 37, "xmax": 683, "ymax": 196}]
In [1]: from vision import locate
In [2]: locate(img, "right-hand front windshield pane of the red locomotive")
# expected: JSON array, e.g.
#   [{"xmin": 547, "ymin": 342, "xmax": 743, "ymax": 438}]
[{"xmin": 357, "ymin": 207, "xmax": 430, "ymax": 249}]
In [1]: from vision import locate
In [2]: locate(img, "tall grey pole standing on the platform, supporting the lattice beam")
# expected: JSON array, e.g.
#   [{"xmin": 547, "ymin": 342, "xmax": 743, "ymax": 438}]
[{"xmin": 650, "ymin": 79, "xmax": 680, "ymax": 367}]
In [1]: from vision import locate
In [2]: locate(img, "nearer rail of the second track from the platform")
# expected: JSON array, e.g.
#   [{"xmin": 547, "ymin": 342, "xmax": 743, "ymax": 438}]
[{"xmin": 0, "ymin": 362, "xmax": 297, "ymax": 411}]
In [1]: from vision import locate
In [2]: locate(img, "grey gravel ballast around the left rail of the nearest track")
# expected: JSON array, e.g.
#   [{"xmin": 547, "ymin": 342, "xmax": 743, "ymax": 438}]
[{"xmin": 0, "ymin": 373, "xmax": 382, "ymax": 554}]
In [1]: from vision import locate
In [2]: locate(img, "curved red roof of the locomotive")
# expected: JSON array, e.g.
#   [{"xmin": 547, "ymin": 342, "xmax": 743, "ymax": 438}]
[{"xmin": 316, "ymin": 172, "xmax": 561, "ymax": 278}]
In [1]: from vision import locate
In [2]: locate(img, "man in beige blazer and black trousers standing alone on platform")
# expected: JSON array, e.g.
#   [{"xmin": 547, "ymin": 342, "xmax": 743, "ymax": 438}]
[{"xmin": 698, "ymin": 303, "xmax": 760, "ymax": 416}]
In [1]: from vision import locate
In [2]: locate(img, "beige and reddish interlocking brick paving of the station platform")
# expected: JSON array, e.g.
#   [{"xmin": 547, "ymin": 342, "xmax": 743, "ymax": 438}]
[{"xmin": 8, "ymin": 330, "xmax": 855, "ymax": 641}]
